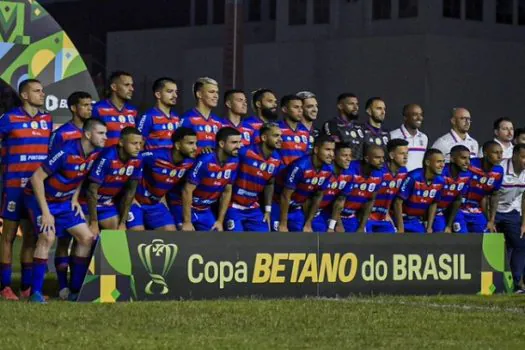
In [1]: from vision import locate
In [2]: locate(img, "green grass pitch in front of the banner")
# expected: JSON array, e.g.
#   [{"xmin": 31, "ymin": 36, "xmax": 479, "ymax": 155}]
[{"xmin": 0, "ymin": 239, "xmax": 525, "ymax": 349}]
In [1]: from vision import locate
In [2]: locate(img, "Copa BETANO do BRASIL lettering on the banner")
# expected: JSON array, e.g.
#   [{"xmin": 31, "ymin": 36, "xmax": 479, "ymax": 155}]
[{"xmin": 187, "ymin": 252, "xmax": 472, "ymax": 289}]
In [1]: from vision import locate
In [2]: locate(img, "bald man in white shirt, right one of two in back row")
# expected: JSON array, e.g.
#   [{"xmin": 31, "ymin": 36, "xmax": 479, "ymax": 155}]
[{"xmin": 432, "ymin": 107, "xmax": 479, "ymax": 162}]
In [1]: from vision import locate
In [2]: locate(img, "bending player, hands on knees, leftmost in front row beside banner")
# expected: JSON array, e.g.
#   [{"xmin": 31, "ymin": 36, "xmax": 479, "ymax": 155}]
[{"xmin": 24, "ymin": 119, "xmax": 107, "ymax": 303}]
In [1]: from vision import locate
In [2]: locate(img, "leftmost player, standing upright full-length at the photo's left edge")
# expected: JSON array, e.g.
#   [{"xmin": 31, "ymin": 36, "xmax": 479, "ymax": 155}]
[{"xmin": 0, "ymin": 79, "xmax": 53, "ymax": 300}]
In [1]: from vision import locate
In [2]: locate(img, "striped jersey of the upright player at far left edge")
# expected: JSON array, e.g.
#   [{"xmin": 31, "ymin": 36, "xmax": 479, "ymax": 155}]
[{"xmin": 0, "ymin": 107, "xmax": 53, "ymax": 188}]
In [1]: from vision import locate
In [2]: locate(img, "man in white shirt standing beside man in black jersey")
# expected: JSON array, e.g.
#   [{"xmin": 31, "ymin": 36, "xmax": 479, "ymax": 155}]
[{"xmin": 390, "ymin": 104, "xmax": 428, "ymax": 171}]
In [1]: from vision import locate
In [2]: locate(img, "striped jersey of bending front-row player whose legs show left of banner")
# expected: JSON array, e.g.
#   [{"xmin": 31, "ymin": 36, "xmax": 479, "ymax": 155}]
[{"xmin": 25, "ymin": 140, "xmax": 100, "ymax": 203}]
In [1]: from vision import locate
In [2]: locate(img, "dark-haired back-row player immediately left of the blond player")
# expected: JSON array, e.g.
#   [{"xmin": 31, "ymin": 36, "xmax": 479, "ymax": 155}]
[{"xmin": 137, "ymin": 77, "xmax": 180, "ymax": 151}]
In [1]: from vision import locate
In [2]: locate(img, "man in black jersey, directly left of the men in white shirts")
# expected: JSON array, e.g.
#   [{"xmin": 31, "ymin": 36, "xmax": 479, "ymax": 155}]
[{"xmin": 363, "ymin": 97, "xmax": 390, "ymax": 154}]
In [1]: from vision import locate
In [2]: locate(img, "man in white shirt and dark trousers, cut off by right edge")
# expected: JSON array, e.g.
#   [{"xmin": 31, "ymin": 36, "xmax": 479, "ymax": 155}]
[{"xmin": 496, "ymin": 144, "xmax": 525, "ymax": 294}]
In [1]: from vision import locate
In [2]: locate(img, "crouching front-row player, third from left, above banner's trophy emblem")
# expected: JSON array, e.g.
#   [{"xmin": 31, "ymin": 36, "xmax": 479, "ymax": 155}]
[{"xmin": 127, "ymin": 127, "xmax": 197, "ymax": 231}]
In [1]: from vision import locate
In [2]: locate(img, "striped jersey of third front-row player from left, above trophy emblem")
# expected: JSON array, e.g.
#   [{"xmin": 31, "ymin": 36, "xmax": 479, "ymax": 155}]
[{"xmin": 135, "ymin": 148, "xmax": 195, "ymax": 205}]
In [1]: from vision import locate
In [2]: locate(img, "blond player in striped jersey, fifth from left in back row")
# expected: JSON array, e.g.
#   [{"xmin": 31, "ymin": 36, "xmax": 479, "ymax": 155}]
[{"xmin": 181, "ymin": 77, "xmax": 224, "ymax": 153}]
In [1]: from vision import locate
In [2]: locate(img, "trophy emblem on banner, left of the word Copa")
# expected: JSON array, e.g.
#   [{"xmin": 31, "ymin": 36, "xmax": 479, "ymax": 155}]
[{"xmin": 137, "ymin": 239, "xmax": 179, "ymax": 295}]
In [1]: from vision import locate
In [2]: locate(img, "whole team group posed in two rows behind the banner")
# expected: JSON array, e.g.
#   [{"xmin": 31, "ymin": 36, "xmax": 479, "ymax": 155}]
[{"xmin": 0, "ymin": 72, "xmax": 525, "ymax": 303}]
